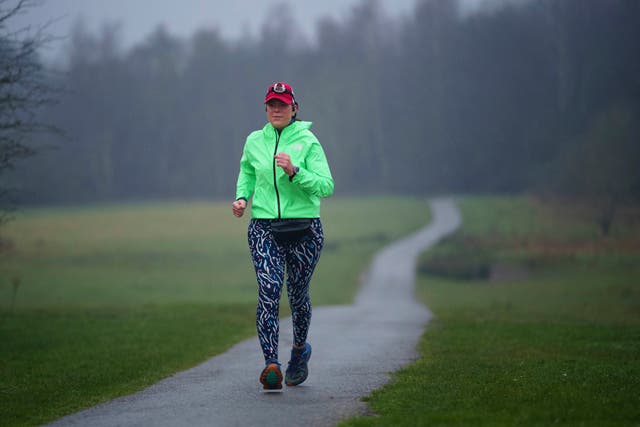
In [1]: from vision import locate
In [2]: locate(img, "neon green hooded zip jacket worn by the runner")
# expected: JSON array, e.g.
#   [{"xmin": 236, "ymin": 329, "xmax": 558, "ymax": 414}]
[{"xmin": 236, "ymin": 121, "xmax": 333, "ymax": 219}]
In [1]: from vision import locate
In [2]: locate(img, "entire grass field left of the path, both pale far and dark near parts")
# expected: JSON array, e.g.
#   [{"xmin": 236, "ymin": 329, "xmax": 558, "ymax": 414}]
[{"xmin": 0, "ymin": 197, "xmax": 429, "ymax": 426}]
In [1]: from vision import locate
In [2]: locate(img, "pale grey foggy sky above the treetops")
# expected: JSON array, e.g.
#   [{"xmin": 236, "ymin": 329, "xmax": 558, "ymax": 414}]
[{"xmin": 10, "ymin": 0, "xmax": 500, "ymax": 59}]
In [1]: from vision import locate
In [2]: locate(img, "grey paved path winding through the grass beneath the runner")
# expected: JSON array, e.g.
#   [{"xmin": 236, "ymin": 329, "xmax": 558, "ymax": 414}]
[{"xmin": 51, "ymin": 200, "xmax": 460, "ymax": 427}]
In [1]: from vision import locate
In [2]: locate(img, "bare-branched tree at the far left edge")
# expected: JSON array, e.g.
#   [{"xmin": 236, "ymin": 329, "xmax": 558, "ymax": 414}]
[{"xmin": 0, "ymin": 0, "xmax": 53, "ymax": 224}]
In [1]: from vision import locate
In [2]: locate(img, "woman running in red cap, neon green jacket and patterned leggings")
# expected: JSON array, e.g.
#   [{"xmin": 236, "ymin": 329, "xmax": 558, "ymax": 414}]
[{"xmin": 233, "ymin": 82, "xmax": 333, "ymax": 390}]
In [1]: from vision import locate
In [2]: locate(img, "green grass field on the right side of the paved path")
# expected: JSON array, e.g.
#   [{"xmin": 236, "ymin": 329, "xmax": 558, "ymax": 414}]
[{"xmin": 341, "ymin": 198, "xmax": 640, "ymax": 426}]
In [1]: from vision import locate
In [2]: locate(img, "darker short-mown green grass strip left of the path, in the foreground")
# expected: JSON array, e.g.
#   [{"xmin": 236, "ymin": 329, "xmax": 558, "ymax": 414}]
[{"xmin": 0, "ymin": 304, "xmax": 255, "ymax": 425}]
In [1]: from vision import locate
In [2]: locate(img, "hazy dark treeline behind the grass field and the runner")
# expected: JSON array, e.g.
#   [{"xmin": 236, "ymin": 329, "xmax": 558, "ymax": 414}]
[{"xmin": 8, "ymin": 0, "xmax": 640, "ymax": 203}]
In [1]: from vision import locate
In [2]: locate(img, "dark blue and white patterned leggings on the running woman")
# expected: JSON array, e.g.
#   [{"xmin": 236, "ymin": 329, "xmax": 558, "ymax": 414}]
[{"xmin": 249, "ymin": 219, "xmax": 324, "ymax": 361}]
